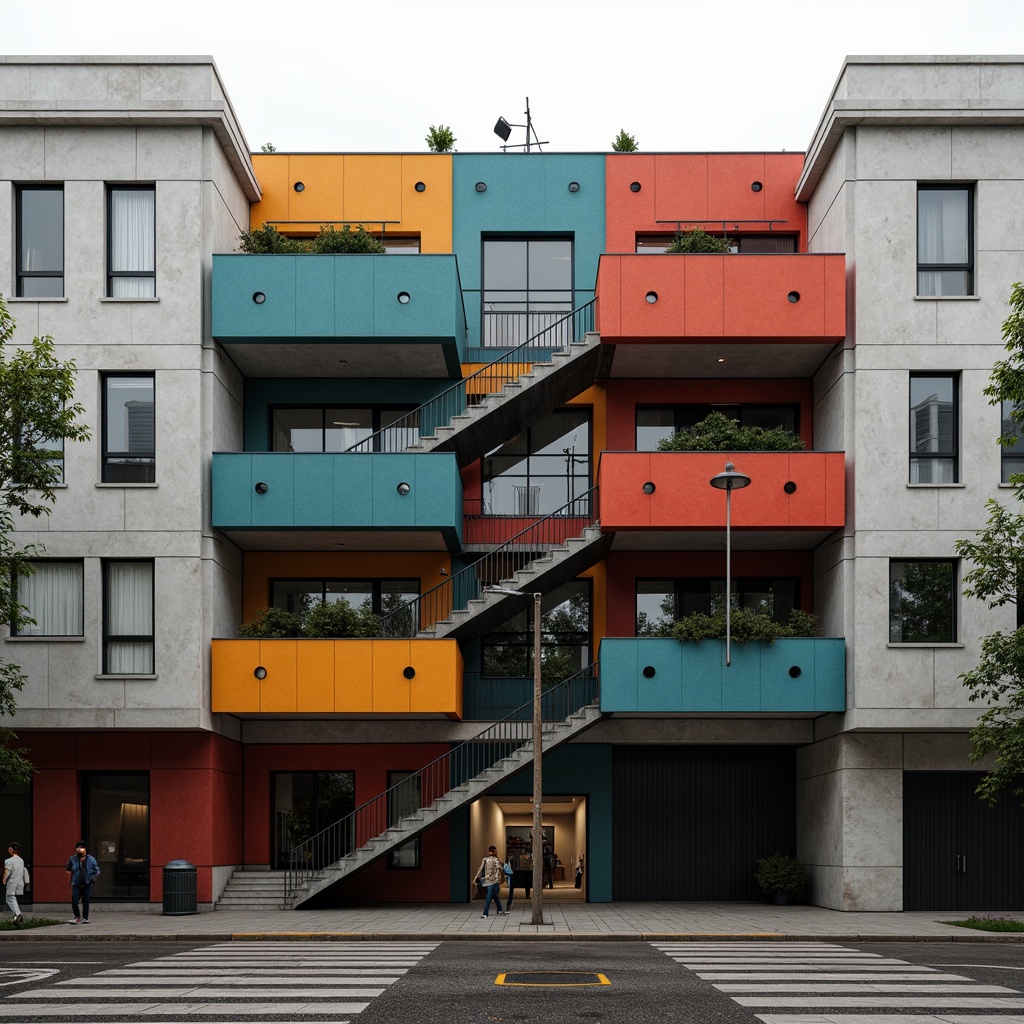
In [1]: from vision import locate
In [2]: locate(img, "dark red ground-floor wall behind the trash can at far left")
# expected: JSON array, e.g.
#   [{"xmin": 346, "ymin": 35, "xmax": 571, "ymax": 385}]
[{"xmin": 23, "ymin": 731, "xmax": 243, "ymax": 903}]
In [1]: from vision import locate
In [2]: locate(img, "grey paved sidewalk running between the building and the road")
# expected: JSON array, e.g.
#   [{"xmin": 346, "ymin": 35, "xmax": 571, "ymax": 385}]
[{"xmin": 0, "ymin": 900, "xmax": 1024, "ymax": 942}]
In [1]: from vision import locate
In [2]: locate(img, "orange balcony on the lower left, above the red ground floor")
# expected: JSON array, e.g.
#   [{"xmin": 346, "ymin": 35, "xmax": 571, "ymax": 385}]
[{"xmin": 212, "ymin": 640, "xmax": 463, "ymax": 721}]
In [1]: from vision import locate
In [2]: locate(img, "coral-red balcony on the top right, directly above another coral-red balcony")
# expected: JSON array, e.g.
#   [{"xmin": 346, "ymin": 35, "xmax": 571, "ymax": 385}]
[{"xmin": 597, "ymin": 253, "xmax": 846, "ymax": 378}]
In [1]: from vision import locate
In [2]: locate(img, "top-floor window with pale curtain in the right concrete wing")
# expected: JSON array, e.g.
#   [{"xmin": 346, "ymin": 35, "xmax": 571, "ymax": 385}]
[{"xmin": 918, "ymin": 185, "xmax": 974, "ymax": 295}]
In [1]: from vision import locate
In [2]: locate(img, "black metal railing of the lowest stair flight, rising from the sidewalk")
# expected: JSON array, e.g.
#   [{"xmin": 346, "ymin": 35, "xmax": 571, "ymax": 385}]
[{"xmin": 285, "ymin": 664, "xmax": 600, "ymax": 906}]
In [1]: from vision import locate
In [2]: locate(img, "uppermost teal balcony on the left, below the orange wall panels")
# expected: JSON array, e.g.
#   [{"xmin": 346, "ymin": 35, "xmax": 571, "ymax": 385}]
[{"xmin": 213, "ymin": 254, "xmax": 466, "ymax": 380}]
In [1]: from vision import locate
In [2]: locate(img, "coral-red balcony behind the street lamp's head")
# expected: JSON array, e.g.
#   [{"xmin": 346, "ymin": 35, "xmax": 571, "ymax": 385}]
[{"xmin": 598, "ymin": 452, "xmax": 846, "ymax": 550}]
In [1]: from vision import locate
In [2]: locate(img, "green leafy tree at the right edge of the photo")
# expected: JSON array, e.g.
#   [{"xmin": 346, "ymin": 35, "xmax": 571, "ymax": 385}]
[{"xmin": 955, "ymin": 282, "xmax": 1024, "ymax": 803}]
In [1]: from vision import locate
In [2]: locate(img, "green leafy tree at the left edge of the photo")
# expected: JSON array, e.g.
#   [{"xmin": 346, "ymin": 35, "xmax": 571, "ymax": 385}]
[{"xmin": 0, "ymin": 296, "xmax": 90, "ymax": 782}]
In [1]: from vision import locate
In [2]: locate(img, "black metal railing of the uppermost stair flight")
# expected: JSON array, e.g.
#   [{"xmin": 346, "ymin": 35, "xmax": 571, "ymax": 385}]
[{"xmin": 345, "ymin": 299, "xmax": 597, "ymax": 452}]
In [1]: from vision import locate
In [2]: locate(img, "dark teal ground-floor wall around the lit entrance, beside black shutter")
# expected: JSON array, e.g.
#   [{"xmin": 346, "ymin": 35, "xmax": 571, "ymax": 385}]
[{"xmin": 485, "ymin": 743, "xmax": 611, "ymax": 903}]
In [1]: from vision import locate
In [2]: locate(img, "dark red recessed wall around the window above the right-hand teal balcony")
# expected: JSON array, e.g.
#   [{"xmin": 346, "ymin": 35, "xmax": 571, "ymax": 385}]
[{"xmin": 605, "ymin": 551, "xmax": 813, "ymax": 637}]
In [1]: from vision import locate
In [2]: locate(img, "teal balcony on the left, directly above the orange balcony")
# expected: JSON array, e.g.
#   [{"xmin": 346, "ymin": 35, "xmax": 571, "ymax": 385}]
[{"xmin": 212, "ymin": 452, "xmax": 462, "ymax": 551}]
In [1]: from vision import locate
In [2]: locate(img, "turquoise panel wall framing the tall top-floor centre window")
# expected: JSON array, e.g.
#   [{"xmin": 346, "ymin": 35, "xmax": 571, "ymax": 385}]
[{"xmin": 452, "ymin": 153, "xmax": 605, "ymax": 346}]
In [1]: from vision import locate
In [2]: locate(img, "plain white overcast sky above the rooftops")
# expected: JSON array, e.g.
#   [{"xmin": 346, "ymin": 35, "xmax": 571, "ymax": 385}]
[{"xmin": 6, "ymin": 0, "xmax": 1024, "ymax": 153}]
